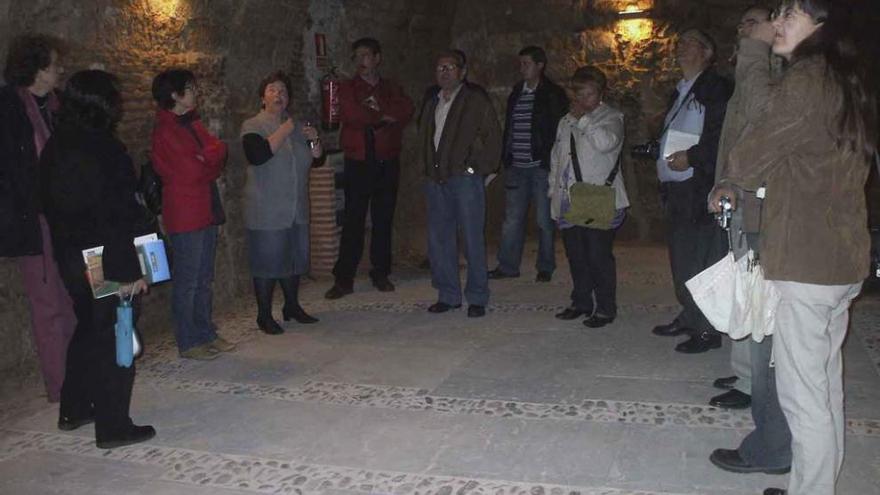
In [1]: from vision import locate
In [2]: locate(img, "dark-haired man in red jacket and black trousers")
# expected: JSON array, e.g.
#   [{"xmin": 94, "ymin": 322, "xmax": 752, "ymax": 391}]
[{"xmin": 324, "ymin": 38, "xmax": 413, "ymax": 299}]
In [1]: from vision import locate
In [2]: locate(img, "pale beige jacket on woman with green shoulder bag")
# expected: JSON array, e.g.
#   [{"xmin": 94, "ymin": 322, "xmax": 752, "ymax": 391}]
[{"xmin": 548, "ymin": 103, "xmax": 629, "ymax": 220}]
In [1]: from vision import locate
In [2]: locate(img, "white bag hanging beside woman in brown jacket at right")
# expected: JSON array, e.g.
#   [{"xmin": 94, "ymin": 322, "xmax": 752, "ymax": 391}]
[{"xmin": 685, "ymin": 250, "xmax": 779, "ymax": 342}]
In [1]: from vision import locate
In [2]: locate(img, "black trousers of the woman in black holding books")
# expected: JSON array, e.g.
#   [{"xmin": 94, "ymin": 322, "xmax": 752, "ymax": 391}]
[{"xmin": 56, "ymin": 249, "xmax": 137, "ymax": 440}]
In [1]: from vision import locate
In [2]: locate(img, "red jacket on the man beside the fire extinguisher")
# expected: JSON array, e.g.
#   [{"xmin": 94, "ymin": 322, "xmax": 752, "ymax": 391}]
[{"xmin": 339, "ymin": 76, "xmax": 413, "ymax": 160}]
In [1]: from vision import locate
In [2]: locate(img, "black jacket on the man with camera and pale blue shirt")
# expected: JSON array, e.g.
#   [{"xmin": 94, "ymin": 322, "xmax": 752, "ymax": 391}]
[{"xmin": 666, "ymin": 67, "xmax": 733, "ymax": 223}]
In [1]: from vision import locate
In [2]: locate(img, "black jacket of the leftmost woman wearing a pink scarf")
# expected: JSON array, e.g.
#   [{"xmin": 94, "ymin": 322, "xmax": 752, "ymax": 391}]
[{"xmin": 0, "ymin": 86, "xmax": 43, "ymax": 257}]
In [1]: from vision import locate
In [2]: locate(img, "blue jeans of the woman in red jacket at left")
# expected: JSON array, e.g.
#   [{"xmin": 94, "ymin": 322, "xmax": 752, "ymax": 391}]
[{"xmin": 169, "ymin": 225, "xmax": 217, "ymax": 352}]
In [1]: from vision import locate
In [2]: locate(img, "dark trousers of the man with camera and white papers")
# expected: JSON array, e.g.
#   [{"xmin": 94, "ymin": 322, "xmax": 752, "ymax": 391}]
[{"xmin": 661, "ymin": 179, "xmax": 727, "ymax": 332}]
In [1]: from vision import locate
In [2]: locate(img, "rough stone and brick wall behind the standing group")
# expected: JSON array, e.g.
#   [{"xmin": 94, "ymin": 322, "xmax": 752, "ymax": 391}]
[{"xmin": 0, "ymin": 0, "xmax": 876, "ymax": 380}]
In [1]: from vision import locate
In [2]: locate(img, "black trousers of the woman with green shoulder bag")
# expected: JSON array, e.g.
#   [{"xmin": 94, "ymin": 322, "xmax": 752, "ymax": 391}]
[{"xmin": 562, "ymin": 227, "xmax": 617, "ymax": 317}]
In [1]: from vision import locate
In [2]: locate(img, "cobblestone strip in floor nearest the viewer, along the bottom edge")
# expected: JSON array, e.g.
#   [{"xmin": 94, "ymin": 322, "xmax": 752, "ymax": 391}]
[{"xmin": 0, "ymin": 429, "xmax": 696, "ymax": 495}]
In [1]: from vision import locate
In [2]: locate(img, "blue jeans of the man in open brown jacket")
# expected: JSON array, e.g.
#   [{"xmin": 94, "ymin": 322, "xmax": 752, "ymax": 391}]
[{"xmin": 425, "ymin": 175, "xmax": 489, "ymax": 306}]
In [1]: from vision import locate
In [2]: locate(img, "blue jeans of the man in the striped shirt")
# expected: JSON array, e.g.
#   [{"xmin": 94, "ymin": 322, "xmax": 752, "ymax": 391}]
[{"xmin": 498, "ymin": 167, "xmax": 556, "ymax": 275}]
